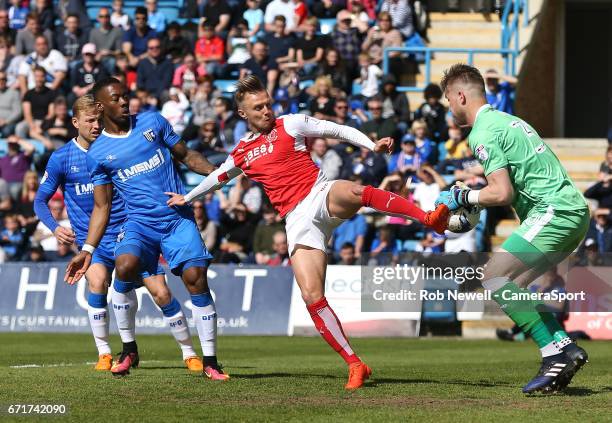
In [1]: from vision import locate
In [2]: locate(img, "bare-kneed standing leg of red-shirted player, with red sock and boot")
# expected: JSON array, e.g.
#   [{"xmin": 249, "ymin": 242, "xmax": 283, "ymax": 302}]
[{"xmin": 291, "ymin": 245, "xmax": 372, "ymax": 389}]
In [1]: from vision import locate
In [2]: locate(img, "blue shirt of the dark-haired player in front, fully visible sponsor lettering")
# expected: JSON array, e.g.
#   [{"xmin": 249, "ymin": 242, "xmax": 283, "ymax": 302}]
[{"xmin": 87, "ymin": 112, "xmax": 185, "ymax": 224}]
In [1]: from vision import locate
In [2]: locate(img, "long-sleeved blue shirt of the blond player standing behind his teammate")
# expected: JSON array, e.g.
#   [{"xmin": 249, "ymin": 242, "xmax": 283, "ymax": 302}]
[{"xmin": 37, "ymin": 139, "xmax": 127, "ymax": 246}]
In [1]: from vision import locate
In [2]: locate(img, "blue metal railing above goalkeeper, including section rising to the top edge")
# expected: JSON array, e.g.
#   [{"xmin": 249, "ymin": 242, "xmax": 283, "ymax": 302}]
[{"xmin": 383, "ymin": 0, "xmax": 529, "ymax": 92}]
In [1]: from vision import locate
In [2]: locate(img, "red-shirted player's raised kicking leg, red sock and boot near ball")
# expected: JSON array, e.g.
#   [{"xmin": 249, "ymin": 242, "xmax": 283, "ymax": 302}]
[{"xmin": 327, "ymin": 181, "xmax": 449, "ymax": 233}]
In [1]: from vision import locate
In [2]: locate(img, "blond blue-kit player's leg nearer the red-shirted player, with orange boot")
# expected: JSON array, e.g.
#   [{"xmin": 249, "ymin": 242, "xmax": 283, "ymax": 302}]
[{"xmin": 143, "ymin": 274, "xmax": 204, "ymax": 372}]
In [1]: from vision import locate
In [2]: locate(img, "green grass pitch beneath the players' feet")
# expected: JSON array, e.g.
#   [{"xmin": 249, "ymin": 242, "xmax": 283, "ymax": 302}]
[{"xmin": 0, "ymin": 333, "xmax": 612, "ymax": 423}]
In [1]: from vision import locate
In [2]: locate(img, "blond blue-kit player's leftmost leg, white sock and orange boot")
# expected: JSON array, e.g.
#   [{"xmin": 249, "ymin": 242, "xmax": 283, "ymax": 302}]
[{"xmin": 85, "ymin": 263, "xmax": 113, "ymax": 370}]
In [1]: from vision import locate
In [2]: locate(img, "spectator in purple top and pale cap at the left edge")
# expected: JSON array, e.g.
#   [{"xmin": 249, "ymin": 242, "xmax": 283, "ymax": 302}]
[{"xmin": 0, "ymin": 135, "xmax": 34, "ymax": 201}]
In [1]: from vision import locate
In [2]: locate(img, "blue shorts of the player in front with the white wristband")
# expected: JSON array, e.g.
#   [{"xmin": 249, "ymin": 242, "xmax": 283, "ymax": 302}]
[{"xmin": 115, "ymin": 217, "xmax": 212, "ymax": 275}]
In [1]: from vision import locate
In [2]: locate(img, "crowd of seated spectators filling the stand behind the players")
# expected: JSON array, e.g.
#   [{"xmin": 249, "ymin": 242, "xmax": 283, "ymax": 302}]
[{"xmin": 0, "ymin": 0, "xmax": 612, "ymax": 265}]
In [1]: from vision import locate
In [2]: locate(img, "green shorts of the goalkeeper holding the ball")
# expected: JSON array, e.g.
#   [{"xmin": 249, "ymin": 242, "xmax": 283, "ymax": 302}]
[{"xmin": 502, "ymin": 206, "xmax": 590, "ymax": 268}]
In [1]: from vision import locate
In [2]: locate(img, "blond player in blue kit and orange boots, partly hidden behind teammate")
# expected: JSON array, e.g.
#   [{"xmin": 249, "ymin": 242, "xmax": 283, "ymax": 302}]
[{"xmin": 34, "ymin": 95, "xmax": 203, "ymax": 373}]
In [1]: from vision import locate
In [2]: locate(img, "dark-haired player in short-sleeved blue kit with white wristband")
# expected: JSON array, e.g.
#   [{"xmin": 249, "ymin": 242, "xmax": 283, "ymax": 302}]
[{"xmin": 65, "ymin": 78, "xmax": 229, "ymax": 380}]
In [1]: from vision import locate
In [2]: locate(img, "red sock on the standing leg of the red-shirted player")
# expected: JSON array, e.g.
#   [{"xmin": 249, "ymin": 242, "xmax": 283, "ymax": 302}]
[{"xmin": 306, "ymin": 297, "xmax": 361, "ymax": 365}]
